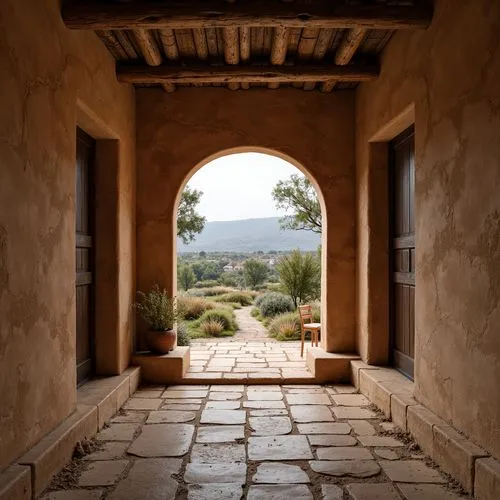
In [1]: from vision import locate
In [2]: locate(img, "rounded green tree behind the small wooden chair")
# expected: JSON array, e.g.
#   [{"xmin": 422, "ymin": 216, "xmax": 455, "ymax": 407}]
[{"xmin": 277, "ymin": 250, "xmax": 321, "ymax": 307}]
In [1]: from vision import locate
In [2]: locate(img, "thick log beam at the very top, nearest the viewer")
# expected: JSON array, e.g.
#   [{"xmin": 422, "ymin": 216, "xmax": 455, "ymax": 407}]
[{"xmin": 62, "ymin": 0, "xmax": 432, "ymax": 30}]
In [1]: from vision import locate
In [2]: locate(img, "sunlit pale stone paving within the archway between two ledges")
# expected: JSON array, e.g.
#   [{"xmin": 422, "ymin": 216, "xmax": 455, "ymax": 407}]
[{"xmin": 186, "ymin": 339, "xmax": 314, "ymax": 383}]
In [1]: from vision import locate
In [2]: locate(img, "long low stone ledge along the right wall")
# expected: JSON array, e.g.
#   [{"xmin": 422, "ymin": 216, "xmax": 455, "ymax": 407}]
[{"xmin": 351, "ymin": 361, "xmax": 494, "ymax": 500}]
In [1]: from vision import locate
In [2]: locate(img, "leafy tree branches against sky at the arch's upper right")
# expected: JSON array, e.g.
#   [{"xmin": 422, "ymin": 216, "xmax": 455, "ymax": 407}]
[{"xmin": 272, "ymin": 174, "xmax": 321, "ymax": 233}]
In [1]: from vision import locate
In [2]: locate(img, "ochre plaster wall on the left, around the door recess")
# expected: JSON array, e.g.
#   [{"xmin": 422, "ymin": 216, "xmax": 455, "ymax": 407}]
[{"xmin": 0, "ymin": 0, "xmax": 135, "ymax": 469}]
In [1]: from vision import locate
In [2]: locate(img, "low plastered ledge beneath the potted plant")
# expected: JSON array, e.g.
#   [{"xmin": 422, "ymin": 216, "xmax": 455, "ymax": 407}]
[{"xmin": 132, "ymin": 347, "xmax": 190, "ymax": 384}]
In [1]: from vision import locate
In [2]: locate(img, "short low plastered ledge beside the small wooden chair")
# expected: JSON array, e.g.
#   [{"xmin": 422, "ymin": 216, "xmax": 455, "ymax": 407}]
[{"xmin": 304, "ymin": 347, "xmax": 359, "ymax": 384}]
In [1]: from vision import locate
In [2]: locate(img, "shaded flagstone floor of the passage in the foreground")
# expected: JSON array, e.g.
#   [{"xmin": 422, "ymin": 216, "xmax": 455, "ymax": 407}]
[{"xmin": 43, "ymin": 385, "xmax": 468, "ymax": 500}]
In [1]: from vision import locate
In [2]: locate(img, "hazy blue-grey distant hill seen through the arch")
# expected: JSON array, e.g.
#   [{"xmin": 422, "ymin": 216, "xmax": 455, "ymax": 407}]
[{"xmin": 177, "ymin": 217, "xmax": 321, "ymax": 252}]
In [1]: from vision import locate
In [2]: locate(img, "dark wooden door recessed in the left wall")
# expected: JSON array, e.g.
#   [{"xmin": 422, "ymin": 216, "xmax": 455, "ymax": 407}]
[{"xmin": 75, "ymin": 129, "xmax": 95, "ymax": 384}]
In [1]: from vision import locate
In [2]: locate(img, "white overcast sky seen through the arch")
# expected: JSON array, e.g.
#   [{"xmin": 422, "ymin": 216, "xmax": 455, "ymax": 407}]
[{"xmin": 188, "ymin": 153, "xmax": 300, "ymax": 221}]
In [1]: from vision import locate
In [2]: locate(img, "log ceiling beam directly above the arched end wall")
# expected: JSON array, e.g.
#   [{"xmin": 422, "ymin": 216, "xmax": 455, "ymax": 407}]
[{"xmin": 116, "ymin": 64, "xmax": 379, "ymax": 84}]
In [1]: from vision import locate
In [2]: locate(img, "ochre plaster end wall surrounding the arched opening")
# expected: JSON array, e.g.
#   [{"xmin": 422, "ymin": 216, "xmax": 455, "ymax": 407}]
[{"xmin": 136, "ymin": 88, "xmax": 355, "ymax": 352}]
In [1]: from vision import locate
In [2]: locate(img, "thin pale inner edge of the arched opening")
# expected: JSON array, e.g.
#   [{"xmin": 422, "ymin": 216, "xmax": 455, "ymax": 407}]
[{"xmin": 171, "ymin": 146, "xmax": 328, "ymax": 348}]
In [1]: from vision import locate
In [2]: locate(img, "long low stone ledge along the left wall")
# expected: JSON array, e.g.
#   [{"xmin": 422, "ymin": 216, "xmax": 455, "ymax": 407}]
[{"xmin": 14, "ymin": 367, "xmax": 139, "ymax": 500}]
